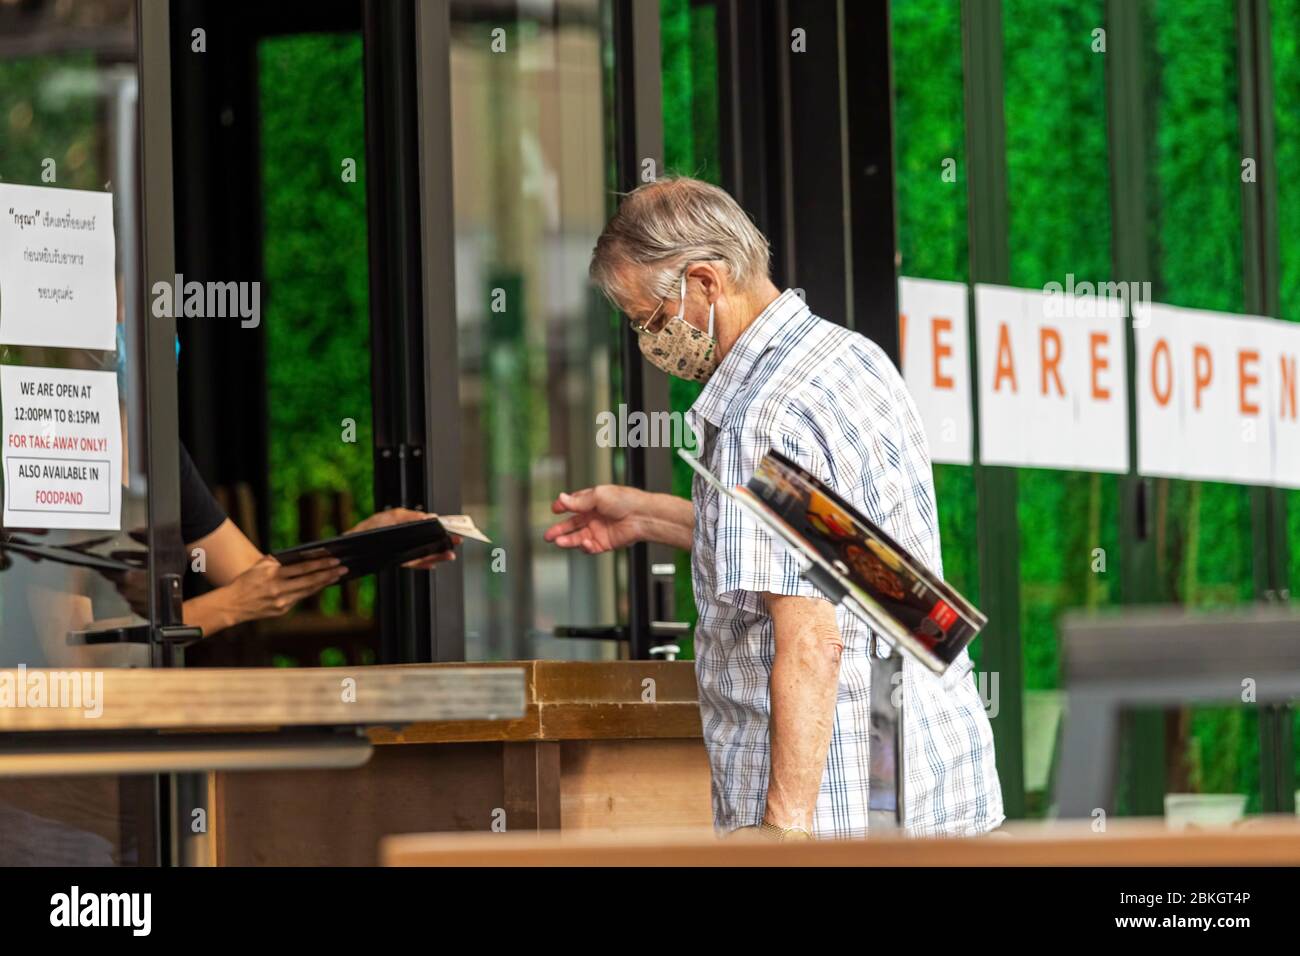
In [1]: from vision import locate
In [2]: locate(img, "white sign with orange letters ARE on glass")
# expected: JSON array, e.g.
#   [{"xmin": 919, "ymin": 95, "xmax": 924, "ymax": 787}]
[{"xmin": 975, "ymin": 285, "xmax": 1128, "ymax": 472}]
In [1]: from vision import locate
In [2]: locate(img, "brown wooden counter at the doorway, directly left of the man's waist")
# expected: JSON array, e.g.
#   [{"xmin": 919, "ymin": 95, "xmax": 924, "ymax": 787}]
[{"xmin": 213, "ymin": 661, "xmax": 712, "ymax": 865}]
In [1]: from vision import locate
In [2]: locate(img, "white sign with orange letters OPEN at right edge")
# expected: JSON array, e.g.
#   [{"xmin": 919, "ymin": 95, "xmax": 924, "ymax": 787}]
[{"xmin": 1134, "ymin": 304, "xmax": 1300, "ymax": 488}]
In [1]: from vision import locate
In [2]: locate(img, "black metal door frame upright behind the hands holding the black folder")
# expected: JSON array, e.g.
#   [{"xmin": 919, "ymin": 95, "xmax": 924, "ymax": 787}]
[{"xmin": 363, "ymin": 0, "xmax": 454, "ymax": 663}]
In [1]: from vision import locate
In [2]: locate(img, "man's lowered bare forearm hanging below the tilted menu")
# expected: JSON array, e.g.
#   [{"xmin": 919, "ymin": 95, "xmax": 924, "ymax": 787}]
[{"xmin": 764, "ymin": 593, "xmax": 844, "ymax": 832}]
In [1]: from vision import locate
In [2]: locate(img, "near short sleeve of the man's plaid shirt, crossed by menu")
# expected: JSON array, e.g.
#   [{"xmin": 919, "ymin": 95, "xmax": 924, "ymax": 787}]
[{"xmin": 714, "ymin": 403, "xmax": 829, "ymax": 614}]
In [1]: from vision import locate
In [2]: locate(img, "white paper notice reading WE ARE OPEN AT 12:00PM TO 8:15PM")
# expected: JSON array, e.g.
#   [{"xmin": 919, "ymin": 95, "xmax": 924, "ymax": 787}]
[{"xmin": 0, "ymin": 365, "xmax": 122, "ymax": 531}]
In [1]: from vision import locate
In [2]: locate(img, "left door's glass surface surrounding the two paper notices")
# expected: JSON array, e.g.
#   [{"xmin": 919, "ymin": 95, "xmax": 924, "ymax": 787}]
[{"xmin": 0, "ymin": 0, "xmax": 155, "ymax": 865}]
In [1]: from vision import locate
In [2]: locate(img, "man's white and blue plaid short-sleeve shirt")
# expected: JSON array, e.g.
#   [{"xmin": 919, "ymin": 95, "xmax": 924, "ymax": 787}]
[{"xmin": 688, "ymin": 290, "xmax": 1004, "ymax": 836}]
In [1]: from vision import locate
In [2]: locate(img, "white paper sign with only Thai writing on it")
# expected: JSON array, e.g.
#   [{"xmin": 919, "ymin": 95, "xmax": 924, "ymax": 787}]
[{"xmin": 0, "ymin": 183, "xmax": 117, "ymax": 351}]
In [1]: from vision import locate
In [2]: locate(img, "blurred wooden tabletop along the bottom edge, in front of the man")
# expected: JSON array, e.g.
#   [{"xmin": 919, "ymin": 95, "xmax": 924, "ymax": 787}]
[{"xmin": 381, "ymin": 817, "xmax": 1300, "ymax": 866}]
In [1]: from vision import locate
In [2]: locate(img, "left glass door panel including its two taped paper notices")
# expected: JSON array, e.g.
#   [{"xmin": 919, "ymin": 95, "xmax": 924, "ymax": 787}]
[{"xmin": 0, "ymin": 0, "xmax": 157, "ymax": 865}]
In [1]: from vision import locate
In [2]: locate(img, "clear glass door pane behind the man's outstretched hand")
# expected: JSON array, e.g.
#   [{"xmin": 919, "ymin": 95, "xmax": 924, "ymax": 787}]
[{"xmin": 450, "ymin": 0, "xmax": 623, "ymax": 659}]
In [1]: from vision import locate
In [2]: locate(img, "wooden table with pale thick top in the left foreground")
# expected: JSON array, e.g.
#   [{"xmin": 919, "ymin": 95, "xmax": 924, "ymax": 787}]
[{"xmin": 0, "ymin": 666, "xmax": 525, "ymax": 861}]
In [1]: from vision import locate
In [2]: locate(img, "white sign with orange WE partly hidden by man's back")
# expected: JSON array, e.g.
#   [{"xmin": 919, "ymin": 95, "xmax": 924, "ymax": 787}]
[{"xmin": 898, "ymin": 278, "xmax": 972, "ymax": 464}]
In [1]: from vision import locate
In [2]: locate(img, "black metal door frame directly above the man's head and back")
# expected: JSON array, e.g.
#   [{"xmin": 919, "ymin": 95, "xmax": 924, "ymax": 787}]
[{"xmin": 716, "ymin": 0, "xmax": 898, "ymax": 353}]
